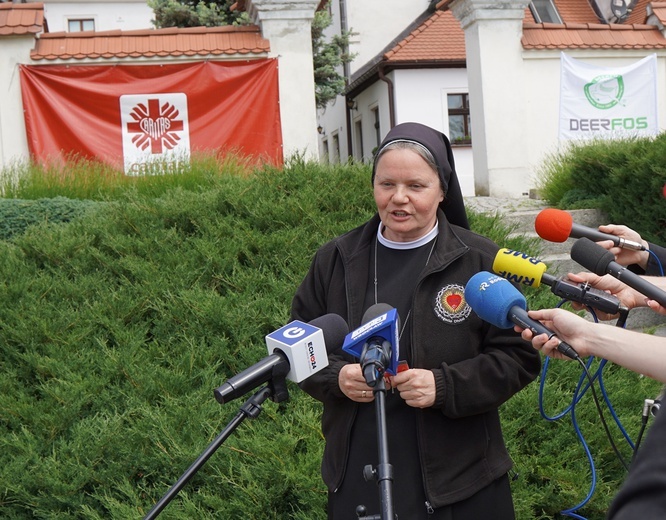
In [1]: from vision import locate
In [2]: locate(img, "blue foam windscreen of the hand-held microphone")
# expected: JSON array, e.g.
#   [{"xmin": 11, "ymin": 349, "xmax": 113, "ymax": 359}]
[{"xmin": 465, "ymin": 271, "xmax": 527, "ymax": 329}]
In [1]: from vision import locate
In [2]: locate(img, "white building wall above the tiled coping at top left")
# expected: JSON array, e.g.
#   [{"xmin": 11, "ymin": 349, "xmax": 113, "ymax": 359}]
[{"xmin": 42, "ymin": 0, "xmax": 155, "ymax": 32}]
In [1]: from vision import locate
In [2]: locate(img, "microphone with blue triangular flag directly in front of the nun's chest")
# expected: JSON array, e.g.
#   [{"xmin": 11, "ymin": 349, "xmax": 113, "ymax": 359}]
[{"xmin": 342, "ymin": 303, "xmax": 399, "ymax": 386}]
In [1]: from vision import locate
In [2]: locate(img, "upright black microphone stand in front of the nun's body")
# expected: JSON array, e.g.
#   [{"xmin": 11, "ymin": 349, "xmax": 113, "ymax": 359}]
[{"xmin": 356, "ymin": 371, "xmax": 398, "ymax": 520}]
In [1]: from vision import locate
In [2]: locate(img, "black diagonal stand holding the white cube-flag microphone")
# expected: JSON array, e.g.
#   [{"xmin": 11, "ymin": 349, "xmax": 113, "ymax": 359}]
[{"xmin": 144, "ymin": 376, "xmax": 289, "ymax": 520}]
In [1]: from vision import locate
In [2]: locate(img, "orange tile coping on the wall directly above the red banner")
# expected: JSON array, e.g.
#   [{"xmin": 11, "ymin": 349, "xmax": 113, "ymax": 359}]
[{"xmin": 30, "ymin": 25, "xmax": 270, "ymax": 61}]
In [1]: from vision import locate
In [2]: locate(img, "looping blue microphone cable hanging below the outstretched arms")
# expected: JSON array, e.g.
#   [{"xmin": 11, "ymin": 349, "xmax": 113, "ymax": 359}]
[{"xmin": 539, "ymin": 300, "xmax": 635, "ymax": 520}]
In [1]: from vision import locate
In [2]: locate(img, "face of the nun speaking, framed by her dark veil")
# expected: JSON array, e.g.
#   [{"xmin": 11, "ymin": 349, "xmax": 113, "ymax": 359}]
[{"xmin": 373, "ymin": 149, "xmax": 444, "ymax": 242}]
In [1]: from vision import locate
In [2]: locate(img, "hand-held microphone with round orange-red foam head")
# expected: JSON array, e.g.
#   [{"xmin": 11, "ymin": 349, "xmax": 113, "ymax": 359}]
[{"xmin": 534, "ymin": 208, "xmax": 647, "ymax": 251}]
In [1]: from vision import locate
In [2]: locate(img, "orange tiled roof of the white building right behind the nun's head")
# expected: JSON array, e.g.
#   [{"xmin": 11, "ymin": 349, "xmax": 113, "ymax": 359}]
[{"xmin": 384, "ymin": 11, "xmax": 465, "ymax": 63}]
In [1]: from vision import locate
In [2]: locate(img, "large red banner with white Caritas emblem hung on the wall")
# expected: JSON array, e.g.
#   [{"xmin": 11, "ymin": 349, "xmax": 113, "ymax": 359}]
[{"xmin": 20, "ymin": 59, "xmax": 282, "ymax": 175}]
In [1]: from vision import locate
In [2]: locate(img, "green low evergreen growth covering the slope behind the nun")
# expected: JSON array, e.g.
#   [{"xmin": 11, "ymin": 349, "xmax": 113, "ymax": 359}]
[{"xmin": 0, "ymin": 152, "xmax": 659, "ymax": 520}]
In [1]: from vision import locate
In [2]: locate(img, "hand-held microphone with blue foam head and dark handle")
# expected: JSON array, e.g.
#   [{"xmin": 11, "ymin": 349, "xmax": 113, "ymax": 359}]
[{"xmin": 465, "ymin": 271, "xmax": 579, "ymax": 359}]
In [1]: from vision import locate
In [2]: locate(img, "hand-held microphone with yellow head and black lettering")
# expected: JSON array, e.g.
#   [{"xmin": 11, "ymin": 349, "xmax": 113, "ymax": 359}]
[{"xmin": 493, "ymin": 248, "xmax": 628, "ymax": 314}]
